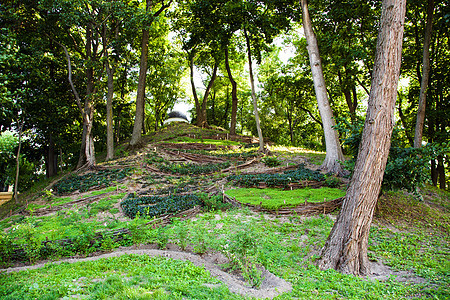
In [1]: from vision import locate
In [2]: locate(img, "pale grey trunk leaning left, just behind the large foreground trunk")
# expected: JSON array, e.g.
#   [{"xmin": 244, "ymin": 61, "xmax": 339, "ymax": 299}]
[{"xmin": 301, "ymin": 0, "xmax": 344, "ymax": 173}]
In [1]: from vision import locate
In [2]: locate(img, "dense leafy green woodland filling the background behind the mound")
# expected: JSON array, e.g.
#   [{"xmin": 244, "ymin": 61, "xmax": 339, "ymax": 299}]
[{"xmin": 0, "ymin": 0, "xmax": 450, "ymax": 191}]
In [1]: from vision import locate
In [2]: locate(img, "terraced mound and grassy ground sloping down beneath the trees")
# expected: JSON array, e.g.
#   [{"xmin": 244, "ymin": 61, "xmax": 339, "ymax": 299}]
[{"xmin": 0, "ymin": 124, "xmax": 450, "ymax": 299}]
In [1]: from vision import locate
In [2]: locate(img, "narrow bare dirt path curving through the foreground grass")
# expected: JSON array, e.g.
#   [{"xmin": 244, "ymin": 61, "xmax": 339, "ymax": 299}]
[{"xmin": 0, "ymin": 249, "xmax": 292, "ymax": 299}]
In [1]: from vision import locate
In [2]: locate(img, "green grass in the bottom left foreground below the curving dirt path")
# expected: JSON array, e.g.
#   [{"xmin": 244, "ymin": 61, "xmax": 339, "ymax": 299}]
[{"xmin": 0, "ymin": 255, "xmax": 236, "ymax": 299}]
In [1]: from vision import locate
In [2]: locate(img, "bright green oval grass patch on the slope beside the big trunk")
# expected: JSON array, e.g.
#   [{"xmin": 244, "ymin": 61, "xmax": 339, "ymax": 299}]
[{"xmin": 225, "ymin": 187, "xmax": 345, "ymax": 209}]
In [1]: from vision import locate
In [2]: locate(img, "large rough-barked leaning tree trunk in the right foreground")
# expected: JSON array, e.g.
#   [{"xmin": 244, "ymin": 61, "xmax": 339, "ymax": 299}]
[{"xmin": 318, "ymin": 0, "xmax": 406, "ymax": 275}]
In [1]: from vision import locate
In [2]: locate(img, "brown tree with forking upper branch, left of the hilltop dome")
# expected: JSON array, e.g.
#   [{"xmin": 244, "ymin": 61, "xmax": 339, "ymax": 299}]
[{"xmin": 130, "ymin": 0, "xmax": 172, "ymax": 147}]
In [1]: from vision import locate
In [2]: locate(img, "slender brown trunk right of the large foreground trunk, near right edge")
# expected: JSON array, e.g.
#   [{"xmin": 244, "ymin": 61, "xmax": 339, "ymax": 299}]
[{"xmin": 414, "ymin": 0, "xmax": 434, "ymax": 148}]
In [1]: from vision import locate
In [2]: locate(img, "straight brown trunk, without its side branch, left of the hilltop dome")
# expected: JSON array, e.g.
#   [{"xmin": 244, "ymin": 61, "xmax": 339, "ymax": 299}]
[{"xmin": 130, "ymin": 1, "xmax": 152, "ymax": 147}]
